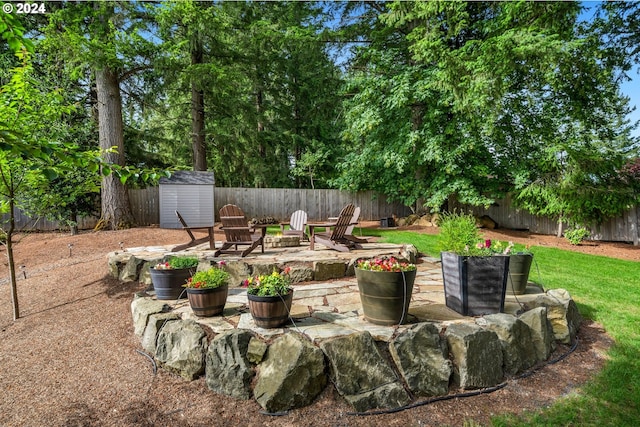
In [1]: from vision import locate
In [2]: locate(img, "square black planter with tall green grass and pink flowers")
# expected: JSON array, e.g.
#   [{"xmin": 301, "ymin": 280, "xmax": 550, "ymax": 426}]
[{"xmin": 439, "ymin": 212, "xmax": 510, "ymax": 316}]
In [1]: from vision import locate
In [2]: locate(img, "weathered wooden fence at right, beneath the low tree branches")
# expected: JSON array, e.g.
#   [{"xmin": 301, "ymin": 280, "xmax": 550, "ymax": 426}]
[{"xmin": 449, "ymin": 196, "xmax": 640, "ymax": 246}]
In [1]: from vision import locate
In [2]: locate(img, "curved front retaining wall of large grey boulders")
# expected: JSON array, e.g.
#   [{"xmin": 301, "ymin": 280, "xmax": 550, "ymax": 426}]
[{"xmin": 131, "ymin": 290, "xmax": 581, "ymax": 412}]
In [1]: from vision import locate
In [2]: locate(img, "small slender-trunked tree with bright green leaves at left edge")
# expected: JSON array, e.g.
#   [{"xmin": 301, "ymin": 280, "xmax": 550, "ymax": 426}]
[{"xmin": 0, "ymin": 14, "xmax": 97, "ymax": 320}]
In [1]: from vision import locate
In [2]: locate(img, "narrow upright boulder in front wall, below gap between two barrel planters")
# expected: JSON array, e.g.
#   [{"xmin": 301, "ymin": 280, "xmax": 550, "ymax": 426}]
[{"xmin": 205, "ymin": 329, "xmax": 254, "ymax": 400}]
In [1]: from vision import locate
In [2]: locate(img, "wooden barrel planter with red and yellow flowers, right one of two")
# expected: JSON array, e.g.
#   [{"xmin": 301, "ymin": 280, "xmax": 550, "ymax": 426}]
[{"xmin": 243, "ymin": 267, "xmax": 293, "ymax": 328}]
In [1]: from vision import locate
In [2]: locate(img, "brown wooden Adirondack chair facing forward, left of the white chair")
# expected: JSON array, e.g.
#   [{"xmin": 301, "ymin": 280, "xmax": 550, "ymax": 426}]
[{"xmin": 213, "ymin": 205, "xmax": 264, "ymax": 257}]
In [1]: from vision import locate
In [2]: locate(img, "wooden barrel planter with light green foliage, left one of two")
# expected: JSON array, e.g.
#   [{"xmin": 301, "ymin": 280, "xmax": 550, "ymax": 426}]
[{"xmin": 184, "ymin": 261, "xmax": 229, "ymax": 317}]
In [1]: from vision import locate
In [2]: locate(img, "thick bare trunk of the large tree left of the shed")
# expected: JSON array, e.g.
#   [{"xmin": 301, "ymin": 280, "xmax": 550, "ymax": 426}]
[{"xmin": 96, "ymin": 66, "xmax": 135, "ymax": 230}]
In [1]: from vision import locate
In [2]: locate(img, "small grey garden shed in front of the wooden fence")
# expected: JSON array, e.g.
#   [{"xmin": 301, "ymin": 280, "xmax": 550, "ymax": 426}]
[{"xmin": 159, "ymin": 171, "xmax": 215, "ymax": 228}]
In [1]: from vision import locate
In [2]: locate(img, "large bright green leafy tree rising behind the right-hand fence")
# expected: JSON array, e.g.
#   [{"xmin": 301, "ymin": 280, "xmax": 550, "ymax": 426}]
[{"xmin": 339, "ymin": 2, "xmax": 633, "ymax": 224}]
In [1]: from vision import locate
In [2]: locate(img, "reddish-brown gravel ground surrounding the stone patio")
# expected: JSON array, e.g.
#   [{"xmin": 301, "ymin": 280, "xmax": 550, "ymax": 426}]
[{"xmin": 0, "ymin": 227, "xmax": 624, "ymax": 427}]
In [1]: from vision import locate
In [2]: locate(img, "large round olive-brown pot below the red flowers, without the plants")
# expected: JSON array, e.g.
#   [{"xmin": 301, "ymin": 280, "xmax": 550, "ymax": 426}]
[{"xmin": 356, "ymin": 268, "xmax": 416, "ymax": 326}]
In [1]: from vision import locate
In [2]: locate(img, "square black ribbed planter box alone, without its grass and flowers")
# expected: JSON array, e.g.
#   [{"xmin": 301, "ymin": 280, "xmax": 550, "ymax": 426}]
[{"xmin": 440, "ymin": 252, "xmax": 509, "ymax": 316}]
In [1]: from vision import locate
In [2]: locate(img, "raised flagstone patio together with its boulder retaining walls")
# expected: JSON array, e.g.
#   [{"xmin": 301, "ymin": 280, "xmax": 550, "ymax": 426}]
[{"xmin": 117, "ymin": 244, "xmax": 581, "ymax": 412}]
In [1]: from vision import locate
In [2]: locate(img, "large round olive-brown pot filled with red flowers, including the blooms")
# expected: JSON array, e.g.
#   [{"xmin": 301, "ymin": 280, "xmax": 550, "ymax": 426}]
[{"xmin": 356, "ymin": 256, "xmax": 416, "ymax": 326}]
